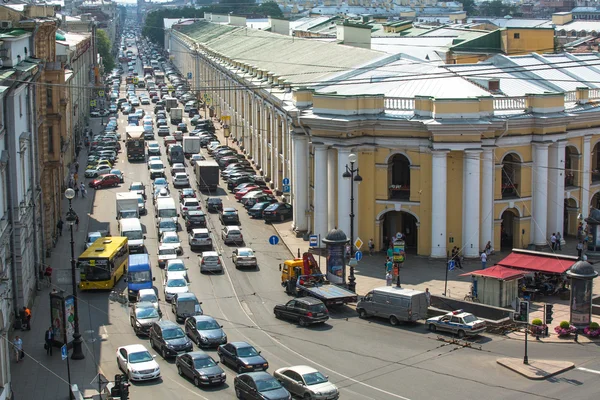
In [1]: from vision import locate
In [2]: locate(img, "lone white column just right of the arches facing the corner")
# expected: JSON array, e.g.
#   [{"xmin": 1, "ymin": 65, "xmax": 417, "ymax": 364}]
[{"xmin": 431, "ymin": 150, "xmax": 448, "ymax": 258}]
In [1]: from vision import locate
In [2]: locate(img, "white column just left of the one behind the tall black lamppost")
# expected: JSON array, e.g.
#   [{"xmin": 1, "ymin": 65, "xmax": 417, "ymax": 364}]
[{"xmin": 313, "ymin": 144, "xmax": 329, "ymax": 244}]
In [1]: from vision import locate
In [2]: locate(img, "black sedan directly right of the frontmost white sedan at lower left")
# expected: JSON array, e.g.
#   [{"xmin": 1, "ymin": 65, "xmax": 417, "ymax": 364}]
[{"xmin": 175, "ymin": 350, "xmax": 226, "ymax": 387}]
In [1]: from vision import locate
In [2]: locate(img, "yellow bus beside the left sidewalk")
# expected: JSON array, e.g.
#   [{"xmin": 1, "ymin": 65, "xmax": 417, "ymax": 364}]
[{"xmin": 77, "ymin": 236, "xmax": 129, "ymax": 290}]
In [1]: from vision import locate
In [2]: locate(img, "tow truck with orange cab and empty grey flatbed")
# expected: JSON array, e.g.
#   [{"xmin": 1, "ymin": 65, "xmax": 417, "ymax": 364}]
[{"xmin": 279, "ymin": 253, "xmax": 357, "ymax": 307}]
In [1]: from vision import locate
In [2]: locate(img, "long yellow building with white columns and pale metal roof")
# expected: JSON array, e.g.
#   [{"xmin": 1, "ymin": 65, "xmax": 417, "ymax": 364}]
[{"xmin": 165, "ymin": 22, "xmax": 600, "ymax": 258}]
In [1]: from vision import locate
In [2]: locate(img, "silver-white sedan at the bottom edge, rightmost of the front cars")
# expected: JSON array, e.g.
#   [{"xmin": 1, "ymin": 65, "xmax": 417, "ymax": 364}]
[{"xmin": 273, "ymin": 365, "xmax": 340, "ymax": 400}]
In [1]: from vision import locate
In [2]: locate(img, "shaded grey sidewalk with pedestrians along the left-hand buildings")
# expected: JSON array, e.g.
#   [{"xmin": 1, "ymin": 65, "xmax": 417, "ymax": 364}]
[{"xmin": 10, "ymin": 119, "xmax": 102, "ymax": 400}]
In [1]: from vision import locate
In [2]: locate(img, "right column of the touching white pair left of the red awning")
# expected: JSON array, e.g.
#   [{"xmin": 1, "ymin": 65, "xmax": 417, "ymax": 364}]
[{"xmin": 479, "ymin": 148, "xmax": 495, "ymax": 247}]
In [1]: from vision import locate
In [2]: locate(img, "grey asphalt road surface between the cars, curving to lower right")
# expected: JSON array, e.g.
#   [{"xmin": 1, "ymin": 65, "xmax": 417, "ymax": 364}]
[{"xmin": 76, "ymin": 43, "xmax": 600, "ymax": 400}]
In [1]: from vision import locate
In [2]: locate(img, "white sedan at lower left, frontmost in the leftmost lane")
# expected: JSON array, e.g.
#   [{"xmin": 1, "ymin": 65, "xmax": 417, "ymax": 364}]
[{"xmin": 117, "ymin": 344, "xmax": 160, "ymax": 381}]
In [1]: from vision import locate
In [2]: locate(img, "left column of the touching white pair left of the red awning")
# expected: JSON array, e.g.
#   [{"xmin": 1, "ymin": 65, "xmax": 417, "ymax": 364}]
[{"xmin": 462, "ymin": 150, "xmax": 481, "ymax": 258}]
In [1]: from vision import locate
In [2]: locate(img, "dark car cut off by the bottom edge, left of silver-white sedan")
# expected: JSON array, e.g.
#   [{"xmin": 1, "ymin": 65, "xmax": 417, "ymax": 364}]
[{"xmin": 233, "ymin": 372, "xmax": 292, "ymax": 400}]
